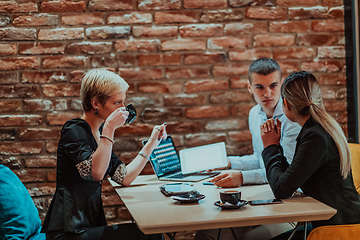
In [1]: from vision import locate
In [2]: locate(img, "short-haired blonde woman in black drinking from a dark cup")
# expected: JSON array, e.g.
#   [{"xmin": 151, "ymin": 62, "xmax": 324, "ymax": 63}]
[{"xmin": 42, "ymin": 69, "xmax": 166, "ymax": 240}]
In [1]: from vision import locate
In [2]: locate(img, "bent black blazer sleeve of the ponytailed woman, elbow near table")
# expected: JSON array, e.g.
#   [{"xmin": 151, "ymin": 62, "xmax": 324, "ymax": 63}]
[{"xmin": 262, "ymin": 131, "xmax": 327, "ymax": 199}]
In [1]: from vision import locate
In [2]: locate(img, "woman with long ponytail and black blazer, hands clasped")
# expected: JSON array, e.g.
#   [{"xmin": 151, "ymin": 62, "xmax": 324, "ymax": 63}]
[{"xmin": 260, "ymin": 71, "xmax": 360, "ymax": 238}]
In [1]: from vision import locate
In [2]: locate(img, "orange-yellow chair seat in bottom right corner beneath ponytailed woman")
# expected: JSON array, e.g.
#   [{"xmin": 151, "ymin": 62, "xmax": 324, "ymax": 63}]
[{"xmin": 307, "ymin": 224, "xmax": 360, "ymax": 240}]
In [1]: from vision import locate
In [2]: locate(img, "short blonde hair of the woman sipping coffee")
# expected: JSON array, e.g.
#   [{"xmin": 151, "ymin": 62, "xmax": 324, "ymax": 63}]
[{"xmin": 80, "ymin": 69, "xmax": 129, "ymax": 112}]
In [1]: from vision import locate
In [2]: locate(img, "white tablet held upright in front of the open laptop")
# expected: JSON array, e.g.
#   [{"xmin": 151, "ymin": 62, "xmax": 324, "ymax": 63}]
[{"xmin": 179, "ymin": 142, "xmax": 228, "ymax": 174}]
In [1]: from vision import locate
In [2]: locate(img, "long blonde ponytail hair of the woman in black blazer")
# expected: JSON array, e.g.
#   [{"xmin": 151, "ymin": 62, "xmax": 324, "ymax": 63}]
[{"xmin": 281, "ymin": 71, "xmax": 351, "ymax": 178}]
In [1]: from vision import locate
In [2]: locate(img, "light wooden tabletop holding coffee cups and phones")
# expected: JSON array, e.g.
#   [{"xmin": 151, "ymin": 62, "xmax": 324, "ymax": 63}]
[{"xmin": 110, "ymin": 175, "xmax": 336, "ymax": 234}]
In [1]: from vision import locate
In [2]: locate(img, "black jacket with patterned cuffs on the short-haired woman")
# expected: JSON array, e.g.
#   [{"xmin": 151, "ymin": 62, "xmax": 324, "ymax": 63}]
[{"xmin": 42, "ymin": 118, "xmax": 122, "ymax": 233}]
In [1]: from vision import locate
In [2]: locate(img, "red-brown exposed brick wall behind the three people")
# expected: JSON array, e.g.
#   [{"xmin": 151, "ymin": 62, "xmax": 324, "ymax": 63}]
[{"xmin": 0, "ymin": 0, "xmax": 347, "ymax": 238}]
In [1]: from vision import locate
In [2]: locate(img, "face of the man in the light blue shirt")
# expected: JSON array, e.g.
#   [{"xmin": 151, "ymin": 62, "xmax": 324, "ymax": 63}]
[{"xmin": 248, "ymin": 71, "xmax": 281, "ymax": 117}]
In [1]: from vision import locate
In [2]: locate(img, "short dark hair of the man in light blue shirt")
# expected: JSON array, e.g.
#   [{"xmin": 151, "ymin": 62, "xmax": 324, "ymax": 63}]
[{"xmin": 249, "ymin": 58, "xmax": 281, "ymax": 83}]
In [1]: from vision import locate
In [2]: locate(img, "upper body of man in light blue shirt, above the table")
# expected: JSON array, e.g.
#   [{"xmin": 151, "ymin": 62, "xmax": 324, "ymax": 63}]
[{"xmin": 212, "ymin": 58, "xmax": 301, "ymax": 187}]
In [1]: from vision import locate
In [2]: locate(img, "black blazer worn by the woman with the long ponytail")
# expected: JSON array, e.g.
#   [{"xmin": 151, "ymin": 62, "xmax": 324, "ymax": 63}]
[{"xmin": 262, "ymin": 117, "xmax": 360, "ymax": 227}]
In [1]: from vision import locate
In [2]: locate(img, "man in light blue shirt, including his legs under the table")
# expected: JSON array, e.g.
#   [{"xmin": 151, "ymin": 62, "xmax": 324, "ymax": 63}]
[{"xmin": 195, "ymin": 58, "xmax": 301, "ymax": 240}]
